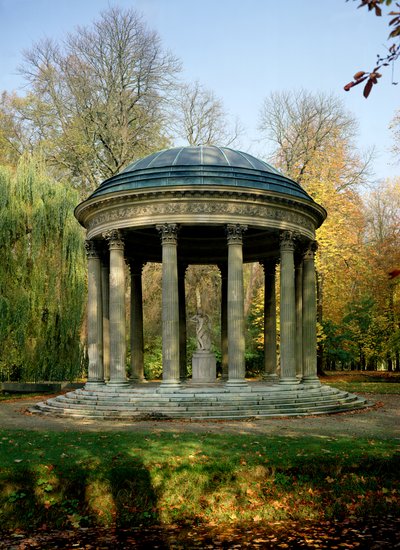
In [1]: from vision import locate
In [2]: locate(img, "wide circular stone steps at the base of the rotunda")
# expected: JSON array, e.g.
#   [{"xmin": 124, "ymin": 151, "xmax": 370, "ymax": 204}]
[{"xmin": 31, "ymin": 385, "xmax": 367, "ymax": 420}]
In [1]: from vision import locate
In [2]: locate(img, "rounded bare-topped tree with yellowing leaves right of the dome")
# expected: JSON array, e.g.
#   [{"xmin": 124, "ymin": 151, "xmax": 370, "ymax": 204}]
[{"xmin": 259, "ymin": 90, "xmax": 372, "ymax": 186}]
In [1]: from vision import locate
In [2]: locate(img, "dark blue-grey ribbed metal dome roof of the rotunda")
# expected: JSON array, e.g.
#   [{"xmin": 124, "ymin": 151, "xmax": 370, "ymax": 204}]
[{"xmin": 90, "ymin": 145, "xmax": 313, "ymax": 202}]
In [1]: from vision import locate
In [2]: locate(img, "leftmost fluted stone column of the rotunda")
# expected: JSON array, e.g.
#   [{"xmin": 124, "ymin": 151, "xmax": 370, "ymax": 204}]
[{"xmin": 85, "ymin": 240, "xmax": 104, "ymax": 386}]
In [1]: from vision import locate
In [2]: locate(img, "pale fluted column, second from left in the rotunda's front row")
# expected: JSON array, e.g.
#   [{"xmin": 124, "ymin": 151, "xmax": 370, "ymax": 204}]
[{"xmin": 103, "ymin": 229, "xmax": 127, "ymax": 385}]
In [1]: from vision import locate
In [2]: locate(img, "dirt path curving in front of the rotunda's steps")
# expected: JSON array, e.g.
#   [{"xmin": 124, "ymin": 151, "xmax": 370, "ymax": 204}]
[{"xmin": 0, "ymin": 395, "xmax": 400, "ymax": 440}]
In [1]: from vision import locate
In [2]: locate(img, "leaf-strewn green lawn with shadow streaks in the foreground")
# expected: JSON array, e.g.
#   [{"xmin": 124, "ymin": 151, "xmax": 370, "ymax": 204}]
[{"xmin": 0, "ymin": 430, "xmax": 400, "ymax": 529}]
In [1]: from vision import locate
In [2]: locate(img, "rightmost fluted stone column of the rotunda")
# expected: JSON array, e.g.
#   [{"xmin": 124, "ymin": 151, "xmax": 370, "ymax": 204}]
[{"xmin": 303, "ymin": 241, "xmax": 319, "ymax": 384}]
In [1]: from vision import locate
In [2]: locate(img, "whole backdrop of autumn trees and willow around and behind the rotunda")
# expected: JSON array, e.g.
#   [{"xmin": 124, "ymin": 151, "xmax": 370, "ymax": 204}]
[{"xmin": 0, "ymin": 8, "xmax": 400, "ymax": 380}]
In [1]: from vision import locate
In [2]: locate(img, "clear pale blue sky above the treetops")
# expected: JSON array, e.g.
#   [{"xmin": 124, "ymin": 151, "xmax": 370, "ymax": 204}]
[{"xmin": 0, "ymin": 0, "xmax": 400, "ymax": 180}]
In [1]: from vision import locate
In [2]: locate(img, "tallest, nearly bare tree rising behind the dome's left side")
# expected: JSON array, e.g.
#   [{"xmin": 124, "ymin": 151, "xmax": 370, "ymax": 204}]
[{"xmin": 20, "ymin": 8, "xmax": 180, "ymax": 189}]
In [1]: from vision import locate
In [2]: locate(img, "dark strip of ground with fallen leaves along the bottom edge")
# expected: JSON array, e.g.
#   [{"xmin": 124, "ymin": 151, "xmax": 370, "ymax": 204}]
[{"xmin": 0, "ymin": 517, "xmax": 400, "ymax": 550}]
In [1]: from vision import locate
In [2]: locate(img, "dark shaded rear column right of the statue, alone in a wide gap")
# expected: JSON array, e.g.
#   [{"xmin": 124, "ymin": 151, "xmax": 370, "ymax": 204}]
[{"xmin": 262, "ymin": 260, "xmax": 278, "ymax": 381}]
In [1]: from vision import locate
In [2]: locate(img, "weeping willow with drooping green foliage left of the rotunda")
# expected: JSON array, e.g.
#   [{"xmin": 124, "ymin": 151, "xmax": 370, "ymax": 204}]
[{"xmin": 0, "ymin": 153, "xmax": 86, "ymax": 381}]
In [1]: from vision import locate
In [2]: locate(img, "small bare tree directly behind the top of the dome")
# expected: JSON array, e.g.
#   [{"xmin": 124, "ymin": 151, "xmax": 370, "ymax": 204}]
[{"xmin": 171, "ymin": 81, "xmax": 242, "ymax": 147}]
